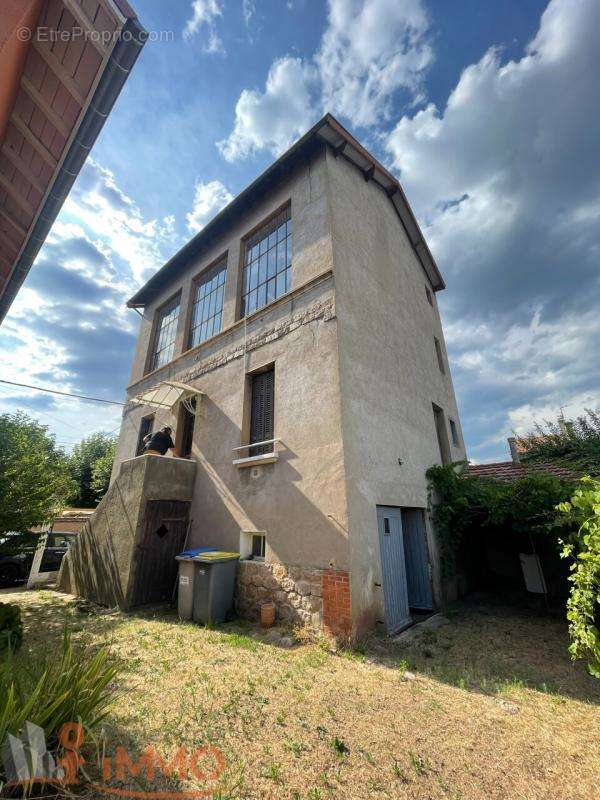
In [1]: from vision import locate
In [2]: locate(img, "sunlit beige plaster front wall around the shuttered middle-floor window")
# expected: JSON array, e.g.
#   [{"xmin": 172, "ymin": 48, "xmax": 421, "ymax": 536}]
[{"xmin": 116, "ymin": 282, "xmax": 348, "ymax": 569}]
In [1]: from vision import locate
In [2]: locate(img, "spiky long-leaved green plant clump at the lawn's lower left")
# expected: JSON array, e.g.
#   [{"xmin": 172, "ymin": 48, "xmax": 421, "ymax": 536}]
[{"xmin": 0, "ymin": 631, "xmax": 118, "ymax": 747}]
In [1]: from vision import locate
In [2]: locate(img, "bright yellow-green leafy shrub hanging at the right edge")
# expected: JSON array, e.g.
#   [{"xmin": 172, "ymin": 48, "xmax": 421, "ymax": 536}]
[{"xmin": 558, "ymin": 477, "xmax": 600, "ymax": 678}]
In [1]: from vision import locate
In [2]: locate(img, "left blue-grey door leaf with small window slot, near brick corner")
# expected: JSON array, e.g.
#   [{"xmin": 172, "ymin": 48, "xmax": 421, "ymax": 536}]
[{"xmin": 377, "ymin": 506, "xmax": 411, "ymax": 635}]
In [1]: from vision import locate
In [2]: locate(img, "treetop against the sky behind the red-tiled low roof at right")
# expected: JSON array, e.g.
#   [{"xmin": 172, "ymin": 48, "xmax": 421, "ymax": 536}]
[{"xmin": 517, "ymin": 409, "xmax": 600, "ymax": 475}]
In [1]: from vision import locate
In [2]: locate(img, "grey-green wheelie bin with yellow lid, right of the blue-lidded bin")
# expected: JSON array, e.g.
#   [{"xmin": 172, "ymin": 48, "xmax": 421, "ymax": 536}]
[{"xmin": 193, "ymin": 550, "xmax": 240, "ymax": 625}]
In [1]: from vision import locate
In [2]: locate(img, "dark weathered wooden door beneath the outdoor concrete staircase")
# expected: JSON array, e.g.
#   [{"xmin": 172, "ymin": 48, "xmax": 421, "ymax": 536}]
[{"xmin": 131, "ymin": 500, "xmax": 190, "ymax": 606}]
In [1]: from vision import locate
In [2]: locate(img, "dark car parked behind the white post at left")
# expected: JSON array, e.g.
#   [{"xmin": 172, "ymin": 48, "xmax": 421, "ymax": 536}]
[{"xmin": 0, "ymin": 531, "xmax": 71, "ymax": 587}]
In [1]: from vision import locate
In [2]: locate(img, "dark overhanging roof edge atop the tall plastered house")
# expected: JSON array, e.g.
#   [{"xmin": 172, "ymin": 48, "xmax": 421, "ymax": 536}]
[{"xmin": 127, "ymin": 114, "xmax": 445, "ymax": 308}]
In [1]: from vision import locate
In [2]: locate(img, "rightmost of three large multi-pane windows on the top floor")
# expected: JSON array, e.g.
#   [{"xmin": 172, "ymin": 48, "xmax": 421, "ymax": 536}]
[{"xmin": 242, "ymin": 206, "xmax": 292, "ymax": 316}]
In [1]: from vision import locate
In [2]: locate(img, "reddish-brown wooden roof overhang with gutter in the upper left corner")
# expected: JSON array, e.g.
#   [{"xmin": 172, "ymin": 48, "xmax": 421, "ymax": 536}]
[{"xmin": 0, "ymin": 0, "xmax": 146, "ymax": 322}]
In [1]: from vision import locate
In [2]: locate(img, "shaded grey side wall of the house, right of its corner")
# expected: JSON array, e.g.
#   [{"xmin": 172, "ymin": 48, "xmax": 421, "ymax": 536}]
[{"xmin": 327, "ymin": 151, "xmax": 465, "ymax": 628}]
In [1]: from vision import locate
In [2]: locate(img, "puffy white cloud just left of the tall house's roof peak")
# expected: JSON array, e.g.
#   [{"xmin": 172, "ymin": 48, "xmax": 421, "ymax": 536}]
[{"xmin": 217, "ymin": 57, "xmax": 315, "ymax": 161}]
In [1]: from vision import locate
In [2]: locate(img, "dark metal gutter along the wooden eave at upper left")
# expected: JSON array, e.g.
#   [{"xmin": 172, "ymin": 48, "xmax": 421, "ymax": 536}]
[{"xmin": 0, "ymin": 18, "xmax": 147, "ymax": 323}]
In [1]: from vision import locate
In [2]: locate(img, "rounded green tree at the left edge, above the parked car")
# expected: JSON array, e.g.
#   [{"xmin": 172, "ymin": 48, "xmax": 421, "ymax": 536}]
[{"xmin": 0, "ymin": 411, "xmax": 76, "ymax": 532}]
